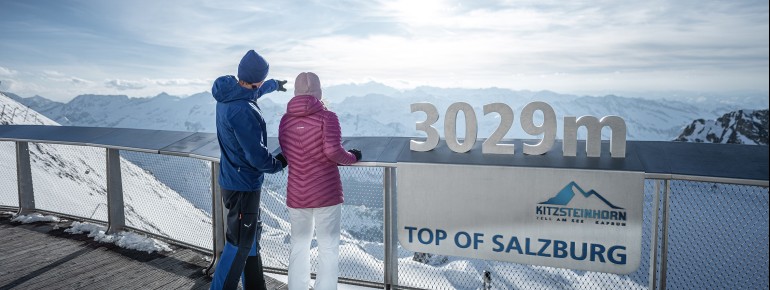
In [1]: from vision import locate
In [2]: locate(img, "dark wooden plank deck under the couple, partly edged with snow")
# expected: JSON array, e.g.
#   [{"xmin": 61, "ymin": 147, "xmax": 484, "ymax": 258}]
[{"xmin": 0, "ymin": 214, "xmax": 287, "ymax": 290}]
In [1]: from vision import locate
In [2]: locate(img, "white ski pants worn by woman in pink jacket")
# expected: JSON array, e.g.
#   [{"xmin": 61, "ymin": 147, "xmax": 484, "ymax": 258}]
[{"xmin": 289, "ymin": 204, "xmax": 342, "ymax": 290}]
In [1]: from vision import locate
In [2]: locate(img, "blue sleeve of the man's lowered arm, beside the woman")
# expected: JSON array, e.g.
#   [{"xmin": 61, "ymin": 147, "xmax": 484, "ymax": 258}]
[{"xmin": 232, "ymin": 109, "xmax": 283, "ymax": 173}]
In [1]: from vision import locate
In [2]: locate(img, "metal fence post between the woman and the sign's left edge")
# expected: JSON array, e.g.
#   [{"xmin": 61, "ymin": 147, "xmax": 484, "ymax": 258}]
[{"xmin": 382, "ymin": 167, "xmax": 398, "ymax": 289}]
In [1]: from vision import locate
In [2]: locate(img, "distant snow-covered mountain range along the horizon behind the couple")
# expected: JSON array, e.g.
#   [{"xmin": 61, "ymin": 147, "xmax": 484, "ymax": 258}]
[{"xmin": 6, "ymin": 83, "xmax": 761, "ymax": 141}]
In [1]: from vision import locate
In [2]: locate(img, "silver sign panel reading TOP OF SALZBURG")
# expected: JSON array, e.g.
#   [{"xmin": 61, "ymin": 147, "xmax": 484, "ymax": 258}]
[{"xmin": 397, "ymin": 163, "xmax": 644, "ymax": 274}]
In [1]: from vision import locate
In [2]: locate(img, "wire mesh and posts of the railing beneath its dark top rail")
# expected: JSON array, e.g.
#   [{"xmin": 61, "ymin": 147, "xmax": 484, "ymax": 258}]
[{"xmin": 0, "ymin": 134, "xmax": 768, "ymax": 289}]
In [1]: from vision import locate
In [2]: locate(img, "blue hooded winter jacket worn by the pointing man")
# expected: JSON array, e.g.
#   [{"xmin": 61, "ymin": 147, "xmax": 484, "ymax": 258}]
[{"xmin": 211, "ymin": 76, "xmax": 282, "ymax": 191}]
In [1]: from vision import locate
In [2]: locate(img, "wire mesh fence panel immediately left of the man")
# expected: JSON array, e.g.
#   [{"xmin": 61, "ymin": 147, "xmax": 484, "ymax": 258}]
[{"xmin": 120, "ymin": 151, "xmax": 213, "ymax": 249}]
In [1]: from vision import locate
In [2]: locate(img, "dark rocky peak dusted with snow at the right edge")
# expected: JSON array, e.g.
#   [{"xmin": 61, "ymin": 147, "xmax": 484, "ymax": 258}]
[{"xmin": 675, "ymin": 109, "xmax": 768, "ymax": 145}]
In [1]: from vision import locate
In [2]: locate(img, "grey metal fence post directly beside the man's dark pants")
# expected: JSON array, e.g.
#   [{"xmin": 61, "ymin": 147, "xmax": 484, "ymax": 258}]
[{"xmin": 205, "ymin": 162, "xmax": 225, "ymax": 275}]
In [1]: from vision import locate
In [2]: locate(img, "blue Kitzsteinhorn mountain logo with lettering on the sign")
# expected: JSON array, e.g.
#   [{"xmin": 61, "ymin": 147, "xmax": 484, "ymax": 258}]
[{"xmin": 535, "ymin": 181, "xmax": 626, "ymax": 227}]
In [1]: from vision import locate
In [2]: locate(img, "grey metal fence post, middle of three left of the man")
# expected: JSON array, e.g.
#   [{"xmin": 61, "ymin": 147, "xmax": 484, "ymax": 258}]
[{"xmin": 107, "ymin": 148, "xmax": 126, "ymax": 234}]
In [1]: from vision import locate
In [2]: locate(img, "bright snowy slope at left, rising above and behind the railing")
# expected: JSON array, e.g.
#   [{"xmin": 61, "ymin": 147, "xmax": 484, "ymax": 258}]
[{"xmin": 0, "ymin": 94, "xmax": 211, "ymax": 247}]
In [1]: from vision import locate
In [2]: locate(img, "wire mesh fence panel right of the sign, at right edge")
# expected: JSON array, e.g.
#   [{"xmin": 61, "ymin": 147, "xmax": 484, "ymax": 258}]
[{"xmin": 666, "ymin": 181, "xmax": 768, "ymax": 289}]
